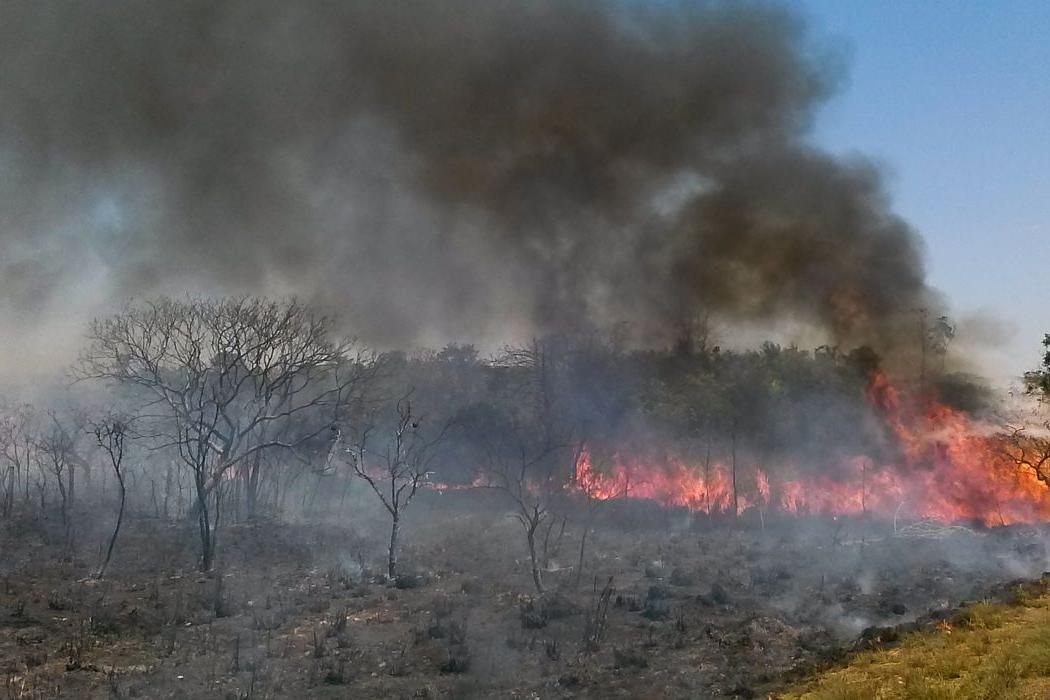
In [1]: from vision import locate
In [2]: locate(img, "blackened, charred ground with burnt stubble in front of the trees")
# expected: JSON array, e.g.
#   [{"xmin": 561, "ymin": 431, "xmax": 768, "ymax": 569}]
[{"xmin": 0, "ymin": 493, "xmax": 1050, "ymax": 698}]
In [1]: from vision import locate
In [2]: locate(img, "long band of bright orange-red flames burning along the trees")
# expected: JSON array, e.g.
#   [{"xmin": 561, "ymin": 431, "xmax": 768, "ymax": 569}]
[{"xmin": 575, "ymin": 374, "xmax": 1050, "ymax": 526}]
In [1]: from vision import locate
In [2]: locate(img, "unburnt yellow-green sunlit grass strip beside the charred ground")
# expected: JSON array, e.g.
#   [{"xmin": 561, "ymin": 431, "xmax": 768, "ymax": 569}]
[{"xmin": 780, "ymin": 593, "xmax": 1050, "ymax": 700}]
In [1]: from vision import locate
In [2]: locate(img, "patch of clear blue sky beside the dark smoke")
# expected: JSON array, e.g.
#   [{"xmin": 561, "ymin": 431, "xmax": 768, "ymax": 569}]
[{"xmin": 792, "ymin": 0, "xmax": 1050, "ymax": 377}]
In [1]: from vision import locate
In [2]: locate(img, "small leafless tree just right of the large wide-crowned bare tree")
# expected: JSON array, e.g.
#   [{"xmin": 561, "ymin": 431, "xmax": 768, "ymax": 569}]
[{"xmin": 350, "ymin": 391, "xmax": 452, "ymax": 578}]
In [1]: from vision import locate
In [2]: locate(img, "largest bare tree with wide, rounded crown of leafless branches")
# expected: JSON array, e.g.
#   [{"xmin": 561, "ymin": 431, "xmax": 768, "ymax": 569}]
[{"xmin": 76, "ymin": 297, "xmax": 377, "ymax": 570}]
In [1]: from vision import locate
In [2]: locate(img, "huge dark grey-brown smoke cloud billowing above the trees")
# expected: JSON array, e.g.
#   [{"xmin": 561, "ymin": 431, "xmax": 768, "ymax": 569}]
[{"xmin": 0, "ymin": 0, "xmax": 928, "ymax": 371}]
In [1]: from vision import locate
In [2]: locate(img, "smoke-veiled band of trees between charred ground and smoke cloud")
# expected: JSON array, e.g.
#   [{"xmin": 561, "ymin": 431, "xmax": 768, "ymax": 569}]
[{"xmin": 0, "ymin": 297, "xmax": 995, "ymax": 590}]
